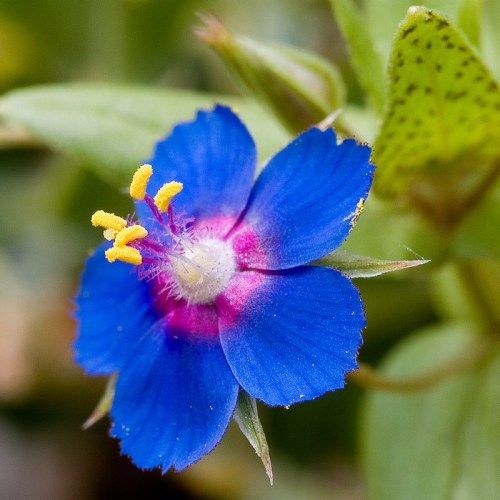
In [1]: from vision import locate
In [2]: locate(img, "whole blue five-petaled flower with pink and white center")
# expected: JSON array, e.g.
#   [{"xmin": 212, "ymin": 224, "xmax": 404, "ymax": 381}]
[{"xmin": 74, "ymin": 105, "xmax": 374, "ymax": 471}]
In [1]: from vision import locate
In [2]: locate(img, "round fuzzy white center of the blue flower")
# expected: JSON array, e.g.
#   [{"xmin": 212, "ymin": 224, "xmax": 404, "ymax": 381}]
[{"xmin": 170, "ymin": 238, "xmax": 236, "ymax": 304}]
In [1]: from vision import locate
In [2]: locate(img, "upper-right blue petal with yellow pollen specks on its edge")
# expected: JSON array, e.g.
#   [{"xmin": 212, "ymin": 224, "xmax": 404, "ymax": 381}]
[{"xmin": 234, "ymin": 128, "xmax": 374, "ymax": 269}]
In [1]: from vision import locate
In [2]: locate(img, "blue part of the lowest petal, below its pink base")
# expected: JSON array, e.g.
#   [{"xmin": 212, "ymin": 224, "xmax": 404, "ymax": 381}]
[{"xmin": 111, "ymin": 321, "xmax": 239, "ymax": 471}]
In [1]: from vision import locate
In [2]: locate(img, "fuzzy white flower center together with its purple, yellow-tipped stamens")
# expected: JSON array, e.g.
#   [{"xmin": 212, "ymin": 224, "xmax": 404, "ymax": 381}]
[{"xmin": 92, "ymin": 165, "xmax": 236, "ymax": 304}]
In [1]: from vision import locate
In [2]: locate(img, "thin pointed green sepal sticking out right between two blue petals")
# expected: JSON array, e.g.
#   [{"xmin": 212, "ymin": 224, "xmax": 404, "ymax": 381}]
[{"xmin": 313, "ymin": 250, "xmax": 429, "ymax": 278}]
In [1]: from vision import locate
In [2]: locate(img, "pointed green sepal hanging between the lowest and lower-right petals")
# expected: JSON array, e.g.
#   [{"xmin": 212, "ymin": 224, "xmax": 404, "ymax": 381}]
[{"xmin": 233, "ymin": 389, "xmax": 273, "ymax": 484}]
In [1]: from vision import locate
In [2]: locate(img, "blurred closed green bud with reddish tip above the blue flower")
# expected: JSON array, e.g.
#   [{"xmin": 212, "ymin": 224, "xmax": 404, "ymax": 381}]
[{"xmin": 195, "ymin": 16, "xmax": 344, "ymax": 133}]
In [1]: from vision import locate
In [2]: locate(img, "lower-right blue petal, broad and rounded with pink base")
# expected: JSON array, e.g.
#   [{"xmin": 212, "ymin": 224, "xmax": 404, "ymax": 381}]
[{"xmin": 217, "ymin": 266, "xmax": 365, "ymax": 406}]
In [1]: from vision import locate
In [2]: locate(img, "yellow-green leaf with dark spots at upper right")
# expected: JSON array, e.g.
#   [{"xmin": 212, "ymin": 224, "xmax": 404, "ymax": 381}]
[{"xmin": 373, "ymin": 7, "xmax": 500, "ymax": 199}]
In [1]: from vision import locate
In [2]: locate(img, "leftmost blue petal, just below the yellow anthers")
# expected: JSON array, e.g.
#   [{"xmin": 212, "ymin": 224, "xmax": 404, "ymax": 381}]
[{"xmin": 74, "ymin": 243, "xmax": 157, "ymax": 375}]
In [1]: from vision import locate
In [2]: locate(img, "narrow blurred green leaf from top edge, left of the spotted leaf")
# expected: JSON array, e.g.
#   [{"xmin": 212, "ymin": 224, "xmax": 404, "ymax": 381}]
[{"xmin": 330, "ymin": 0, "xmax": 387, "ymax": 113}]
